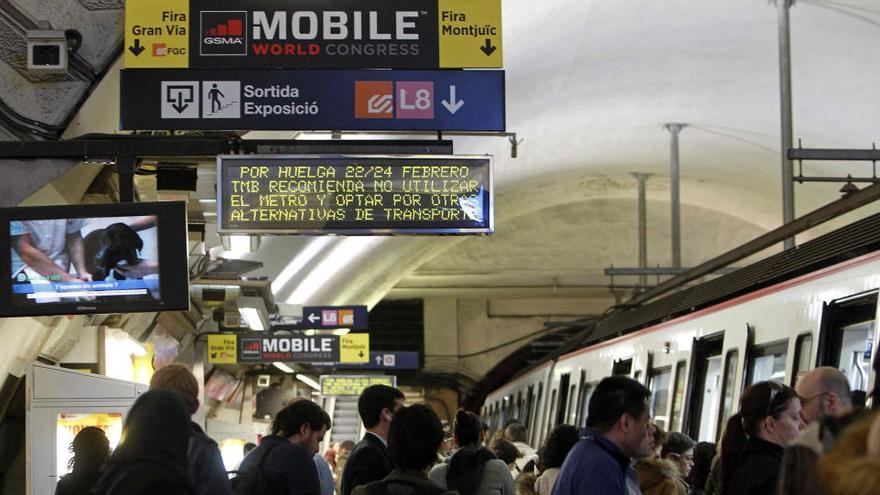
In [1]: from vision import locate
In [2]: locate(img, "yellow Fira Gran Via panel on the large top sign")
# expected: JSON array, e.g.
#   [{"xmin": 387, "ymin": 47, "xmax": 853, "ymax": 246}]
[{"xmin": 124, "ymin": 0, "xmax": 189, "ymax": 69}]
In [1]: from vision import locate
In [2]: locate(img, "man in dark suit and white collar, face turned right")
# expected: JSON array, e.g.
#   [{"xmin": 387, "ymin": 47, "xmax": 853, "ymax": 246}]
[{"xmin": 342, "ymin": 385, "xmax": 405, "ymax": 495}]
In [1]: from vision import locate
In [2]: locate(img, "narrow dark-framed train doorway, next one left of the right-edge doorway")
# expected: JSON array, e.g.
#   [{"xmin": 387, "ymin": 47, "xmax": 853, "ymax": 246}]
[{"xmin": 683, "ymin": 334, "xmax": 724, "ymax": 442}]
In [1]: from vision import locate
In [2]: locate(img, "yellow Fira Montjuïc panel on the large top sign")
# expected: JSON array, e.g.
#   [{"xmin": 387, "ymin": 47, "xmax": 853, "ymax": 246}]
[{"xmin": 437, "ymin": 0, "xmax": 504, "ymax": 68}]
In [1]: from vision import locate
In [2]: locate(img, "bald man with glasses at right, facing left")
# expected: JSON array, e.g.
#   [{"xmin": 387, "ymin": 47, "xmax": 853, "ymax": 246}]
[{"xmin": 777, "ymin": 366, "xmax": 852, "ymax": 495}]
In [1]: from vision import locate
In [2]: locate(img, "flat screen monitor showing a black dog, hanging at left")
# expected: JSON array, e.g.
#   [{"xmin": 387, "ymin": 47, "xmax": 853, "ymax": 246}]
[{"xmin": 0, "ymin": 202, "xmax": 189, "ymax": 317}]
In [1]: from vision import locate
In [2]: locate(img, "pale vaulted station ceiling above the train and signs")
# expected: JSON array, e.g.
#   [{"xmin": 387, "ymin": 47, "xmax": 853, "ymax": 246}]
[{"xmin": 0, "ymin": 0, "xmax": 880, "ymax": 312}]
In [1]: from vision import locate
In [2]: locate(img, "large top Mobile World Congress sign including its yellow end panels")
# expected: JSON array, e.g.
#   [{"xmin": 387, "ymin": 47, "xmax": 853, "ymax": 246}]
[{"xmin": 125, "ymin": 0, "xmax": 502, "ymax": 69}]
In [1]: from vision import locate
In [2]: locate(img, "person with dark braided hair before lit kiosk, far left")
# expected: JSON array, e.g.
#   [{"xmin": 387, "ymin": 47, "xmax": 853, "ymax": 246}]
[{"xmin": 55, "ymin": 426, "xmax": 110, "ymax": 495}]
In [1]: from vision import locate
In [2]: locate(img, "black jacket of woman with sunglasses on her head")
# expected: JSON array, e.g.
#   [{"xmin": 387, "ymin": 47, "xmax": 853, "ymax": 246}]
[{"xmin": 721, "ymin": 437, "xmax": 782, "ymax": 495}]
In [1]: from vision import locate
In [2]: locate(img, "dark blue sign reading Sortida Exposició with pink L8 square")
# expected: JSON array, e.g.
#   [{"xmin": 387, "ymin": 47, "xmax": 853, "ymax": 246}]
[{"xmin": 120, "ymin": 69, "xmax": 505, "ymax": 132}]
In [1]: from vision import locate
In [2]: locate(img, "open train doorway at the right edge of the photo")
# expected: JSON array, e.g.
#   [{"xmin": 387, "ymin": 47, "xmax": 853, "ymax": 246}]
[{"xmin": 816, "ymin": 291, "xmax": 877, "ymax": 402}]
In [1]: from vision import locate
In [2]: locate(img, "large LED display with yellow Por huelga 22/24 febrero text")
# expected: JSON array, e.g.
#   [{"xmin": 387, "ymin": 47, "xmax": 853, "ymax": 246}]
[{"xmin": 217, "ymin": 155, "xmax": 494, "ymax": 235}]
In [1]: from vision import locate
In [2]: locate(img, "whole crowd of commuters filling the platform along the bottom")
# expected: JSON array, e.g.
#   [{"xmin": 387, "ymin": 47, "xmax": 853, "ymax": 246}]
[{"xmin": 56, "ymin": 365, "xmax": 880, "ymax": 495}]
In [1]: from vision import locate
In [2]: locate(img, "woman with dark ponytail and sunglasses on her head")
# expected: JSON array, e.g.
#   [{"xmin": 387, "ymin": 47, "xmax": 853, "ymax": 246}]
[{"xmin": 720, "ymin": 381, "xmax": 804, "ymax": 495}]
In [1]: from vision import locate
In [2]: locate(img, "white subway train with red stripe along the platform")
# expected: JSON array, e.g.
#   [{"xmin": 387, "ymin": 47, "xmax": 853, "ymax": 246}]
[{"xmin": 481, "ymin": 209, "xmax": 880, "ymax": 445}]
